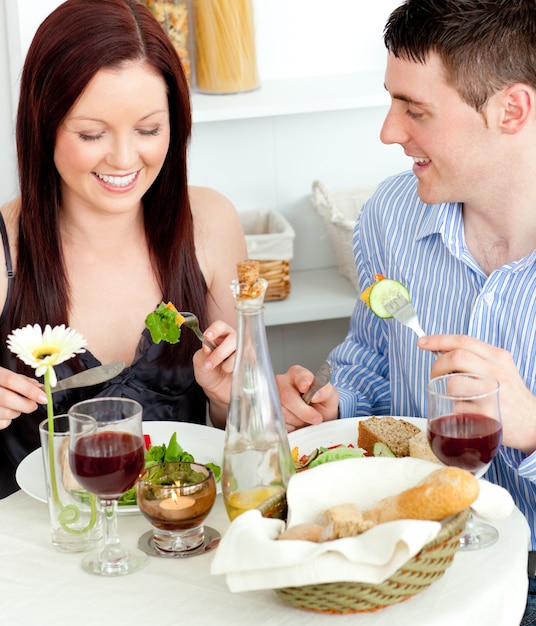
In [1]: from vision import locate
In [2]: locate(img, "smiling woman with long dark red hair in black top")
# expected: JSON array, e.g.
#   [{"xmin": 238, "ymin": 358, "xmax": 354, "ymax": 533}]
[{"xmin": 0, "ymin": 0, "xmax": 246, "ymax": 497}]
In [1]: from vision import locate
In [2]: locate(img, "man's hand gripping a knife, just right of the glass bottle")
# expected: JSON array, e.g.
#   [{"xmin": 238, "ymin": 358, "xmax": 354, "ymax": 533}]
[{"xmin": 275, "ymin": 365, "xmax": 339, "ymax": 432}]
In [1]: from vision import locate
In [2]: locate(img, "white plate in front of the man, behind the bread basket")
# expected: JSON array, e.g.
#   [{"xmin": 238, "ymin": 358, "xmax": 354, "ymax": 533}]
[{"xmin": 288, "ymin": 417, "xmax": 426, "ymax": 456}]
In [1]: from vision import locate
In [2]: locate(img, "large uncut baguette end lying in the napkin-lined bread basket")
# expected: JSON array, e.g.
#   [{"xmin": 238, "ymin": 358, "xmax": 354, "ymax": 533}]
[{"xmin": 363, "ymin": 467, "xmax": 479, "ymax": 524}]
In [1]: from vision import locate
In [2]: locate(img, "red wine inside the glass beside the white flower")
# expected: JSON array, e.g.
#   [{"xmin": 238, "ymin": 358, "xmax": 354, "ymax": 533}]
[{"xmin": 72, "ymin": 431, "xmax": 145, "ymax": 499}]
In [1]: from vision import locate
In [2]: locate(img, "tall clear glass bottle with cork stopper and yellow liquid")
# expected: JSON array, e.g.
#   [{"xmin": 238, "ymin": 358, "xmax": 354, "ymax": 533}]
[{"xmin": 222, "ymin": 262, "xmax": 294, "ymax": 520}]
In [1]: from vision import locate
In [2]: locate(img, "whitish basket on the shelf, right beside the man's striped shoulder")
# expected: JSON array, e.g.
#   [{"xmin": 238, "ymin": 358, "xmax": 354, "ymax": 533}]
[{"xmin": 311, "ymin": 180, "xmax": 375, "ymax": 292}]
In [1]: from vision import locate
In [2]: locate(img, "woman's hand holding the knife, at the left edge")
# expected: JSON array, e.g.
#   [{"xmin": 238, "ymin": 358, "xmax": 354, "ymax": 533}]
[{"xmin": 0, "ymin": 367, "xmax": 47, "ymax": 429}]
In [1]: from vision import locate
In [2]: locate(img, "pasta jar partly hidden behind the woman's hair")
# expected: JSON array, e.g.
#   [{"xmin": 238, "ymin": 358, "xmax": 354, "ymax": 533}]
[{"xmin": 142, "ymin": 0, "xmax": 192, "ymax": 83}]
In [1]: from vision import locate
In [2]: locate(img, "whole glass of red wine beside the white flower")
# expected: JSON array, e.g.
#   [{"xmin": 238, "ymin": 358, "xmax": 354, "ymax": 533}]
[{"xmin": 69, "ymin": 398, "xmax": 148, "ymax": 576}]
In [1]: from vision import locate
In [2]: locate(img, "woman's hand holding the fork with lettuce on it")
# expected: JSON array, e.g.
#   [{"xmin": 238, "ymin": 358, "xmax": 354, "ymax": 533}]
[{"xmin": 193, "ymin": 321, "xmax": 236, "ymax": 428}]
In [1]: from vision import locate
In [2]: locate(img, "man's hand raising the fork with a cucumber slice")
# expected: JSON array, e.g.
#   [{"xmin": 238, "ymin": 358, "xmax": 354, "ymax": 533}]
[{"xmin": 418, "ymin": 335, "xmax": 536, "ymax": 454}]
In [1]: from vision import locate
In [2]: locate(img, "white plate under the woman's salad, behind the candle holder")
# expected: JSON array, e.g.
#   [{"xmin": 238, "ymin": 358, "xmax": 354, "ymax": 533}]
[{"xmin": 15, "ymin": 422, "xmax": 225, "ymax": 515}]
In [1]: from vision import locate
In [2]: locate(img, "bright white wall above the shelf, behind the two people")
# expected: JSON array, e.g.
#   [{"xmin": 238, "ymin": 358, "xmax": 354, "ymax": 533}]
[{"xmin": 11, "ymin": 0, "xmax": 401, "ymax": 80}]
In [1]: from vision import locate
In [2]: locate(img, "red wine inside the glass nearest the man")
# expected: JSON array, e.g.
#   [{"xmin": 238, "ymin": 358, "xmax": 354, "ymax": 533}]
[{"xmin": 428, "ymin": 413, "xmax": 502, "ymax": 476}]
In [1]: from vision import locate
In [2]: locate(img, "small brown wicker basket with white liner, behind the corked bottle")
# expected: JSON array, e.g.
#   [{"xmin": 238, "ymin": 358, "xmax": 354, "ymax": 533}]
[{"xmin": 240, "ymin": 211, "xmax": 295, "ymax": 301}]
